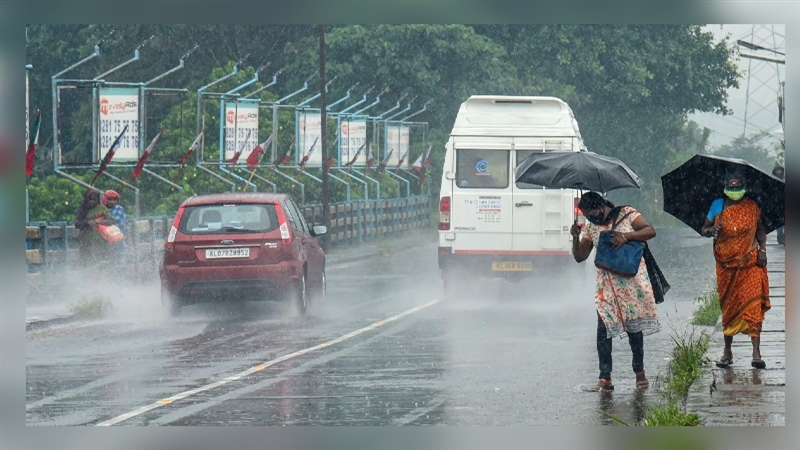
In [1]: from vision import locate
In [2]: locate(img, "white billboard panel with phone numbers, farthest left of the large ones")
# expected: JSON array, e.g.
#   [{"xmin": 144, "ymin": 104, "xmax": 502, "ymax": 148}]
[{"xmin": 94, "ymin": 88, "xmax": 139, "ymax": 163}]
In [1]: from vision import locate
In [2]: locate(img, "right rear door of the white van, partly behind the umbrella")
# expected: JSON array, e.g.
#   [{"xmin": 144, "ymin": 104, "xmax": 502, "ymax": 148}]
[{"xmin": 511, "ymin": 138, "xmax": 574, "ymax": 255}]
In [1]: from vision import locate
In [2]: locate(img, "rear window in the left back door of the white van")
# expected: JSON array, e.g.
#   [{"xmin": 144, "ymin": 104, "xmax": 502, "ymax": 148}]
[{"xmin": 456, "ymin": 149, "xmax": 510, "ymax": 189}]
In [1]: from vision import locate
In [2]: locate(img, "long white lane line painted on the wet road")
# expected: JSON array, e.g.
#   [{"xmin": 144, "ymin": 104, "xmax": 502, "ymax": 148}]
[{"xmin": 95, "ymin": 300, "xmax": 441, "ymax": 427}]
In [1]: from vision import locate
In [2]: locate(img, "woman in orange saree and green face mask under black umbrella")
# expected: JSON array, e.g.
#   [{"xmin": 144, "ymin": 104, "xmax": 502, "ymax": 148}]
[{"xmin": 701, "ymin": 174, "xmax": 770, "ymax": 369}]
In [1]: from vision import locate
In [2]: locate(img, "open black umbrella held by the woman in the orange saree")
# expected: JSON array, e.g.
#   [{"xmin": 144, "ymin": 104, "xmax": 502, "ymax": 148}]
[{"xmin": 661, "ymin": 155, "xmax": 785, "ymax": 233}]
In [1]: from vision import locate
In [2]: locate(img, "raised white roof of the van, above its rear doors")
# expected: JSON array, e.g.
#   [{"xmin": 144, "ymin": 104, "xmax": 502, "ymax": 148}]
[{"xmin": 450, "ymin": 95, "xmax": 581, "ymax": 137}]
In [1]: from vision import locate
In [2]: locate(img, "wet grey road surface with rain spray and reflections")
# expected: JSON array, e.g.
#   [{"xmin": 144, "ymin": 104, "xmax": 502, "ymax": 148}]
[{"xmin": 26, "ymin": 229, "xmax": 713, "ymax": 426}]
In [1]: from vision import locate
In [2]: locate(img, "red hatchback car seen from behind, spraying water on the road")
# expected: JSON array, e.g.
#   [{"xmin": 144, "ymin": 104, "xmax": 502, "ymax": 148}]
[{"xmin": 159, "ymin": 193, "xmax": 327, "ymax": 315}]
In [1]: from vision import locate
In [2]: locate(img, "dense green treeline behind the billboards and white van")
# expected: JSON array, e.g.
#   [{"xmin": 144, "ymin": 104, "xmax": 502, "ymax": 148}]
[{"xmin": 27, "ymin": 24, "xmax": 740, "ymax": 223}]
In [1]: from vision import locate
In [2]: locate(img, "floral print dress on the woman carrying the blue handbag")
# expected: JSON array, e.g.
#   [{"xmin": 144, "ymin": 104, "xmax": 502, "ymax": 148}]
[{"xmin": 581, "ymin": 206, "xmax": 661, "ymax": 339}]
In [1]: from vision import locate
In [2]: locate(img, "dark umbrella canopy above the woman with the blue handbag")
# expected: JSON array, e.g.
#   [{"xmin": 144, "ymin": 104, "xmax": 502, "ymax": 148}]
[{"xmin": 514, "ymin": 152, "xmax": 639, "ymax": 192}]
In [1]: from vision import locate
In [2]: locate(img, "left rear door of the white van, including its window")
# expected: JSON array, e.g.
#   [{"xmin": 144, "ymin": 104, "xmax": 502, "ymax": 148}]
[{"xmin": 450, "ymin": 137, "xmax": 513, "ymax": 254}]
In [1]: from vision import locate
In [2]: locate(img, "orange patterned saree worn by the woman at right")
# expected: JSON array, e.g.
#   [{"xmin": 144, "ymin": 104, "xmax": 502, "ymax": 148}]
[{"xmin": 714, "ymin": 198, "xmax": 770, "ymax": 337}]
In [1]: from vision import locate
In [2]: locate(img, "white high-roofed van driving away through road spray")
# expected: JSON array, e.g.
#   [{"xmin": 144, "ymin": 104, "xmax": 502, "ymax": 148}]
[{"xmin": 439, "ymin": 95, "xmax": 586, "ymax": 297}]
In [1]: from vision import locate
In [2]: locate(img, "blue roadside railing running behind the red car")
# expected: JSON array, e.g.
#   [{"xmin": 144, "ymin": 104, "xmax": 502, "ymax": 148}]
[{"xmin": 25, "ymin": 195, "xmax": 430, "ymax": 284}]
